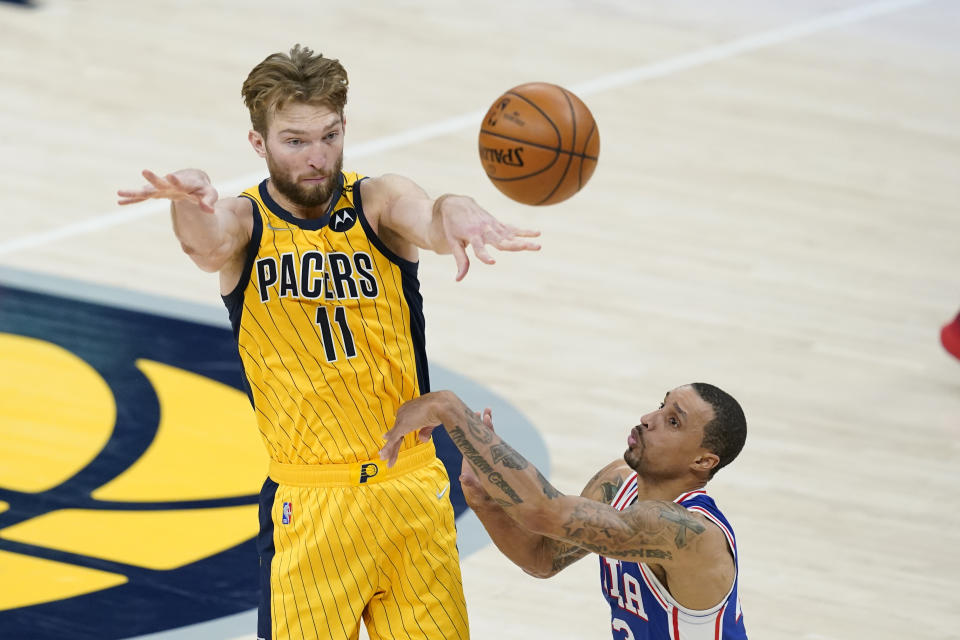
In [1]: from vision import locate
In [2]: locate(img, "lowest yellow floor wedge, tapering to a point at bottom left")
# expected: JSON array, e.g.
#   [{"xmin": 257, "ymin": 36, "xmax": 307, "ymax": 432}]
[{"xmin": 0, "ymin": 551, "xmax": 127, "ymax": 611}]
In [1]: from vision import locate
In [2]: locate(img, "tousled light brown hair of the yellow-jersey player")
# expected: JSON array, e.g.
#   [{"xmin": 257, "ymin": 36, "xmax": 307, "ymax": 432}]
[{"xmin": 242, "ymin": 44, "xmax": 349, "ymax": 135}]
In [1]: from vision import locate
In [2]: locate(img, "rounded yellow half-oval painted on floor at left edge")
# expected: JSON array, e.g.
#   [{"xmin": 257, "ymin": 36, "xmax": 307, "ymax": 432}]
[{"xmin": 0, "ymin": 333, "xmax": 117, "ymax": 492}]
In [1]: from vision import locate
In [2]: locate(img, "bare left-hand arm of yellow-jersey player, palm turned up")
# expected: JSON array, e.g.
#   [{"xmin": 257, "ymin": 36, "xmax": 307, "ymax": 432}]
[{"xmin": 117, "ymin": 169, "xmax": 252, "ymax": 272}]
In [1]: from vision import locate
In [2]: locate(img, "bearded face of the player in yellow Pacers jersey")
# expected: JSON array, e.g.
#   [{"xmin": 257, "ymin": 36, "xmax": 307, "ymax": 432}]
[{"xmin": 250, "ymin": 102, "xmax": 344, "ymax": 208}]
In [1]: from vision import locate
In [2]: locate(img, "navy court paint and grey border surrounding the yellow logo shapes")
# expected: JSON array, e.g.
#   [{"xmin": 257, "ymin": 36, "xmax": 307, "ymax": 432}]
[{"xmin": 0, "ymin": 268, "xmax": 549, "ymax": 640}]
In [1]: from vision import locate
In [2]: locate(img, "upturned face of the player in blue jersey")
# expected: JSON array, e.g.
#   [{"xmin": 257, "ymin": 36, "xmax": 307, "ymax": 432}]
[{"xmin": 623, "ymin": 386, "xmax": 714, "ymax": 479}]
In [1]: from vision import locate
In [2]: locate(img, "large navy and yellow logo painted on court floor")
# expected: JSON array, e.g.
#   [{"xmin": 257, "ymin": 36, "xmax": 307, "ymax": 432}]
[{"xmin": 0, "ymin": 286, "xmax": 444, "ymax": 640}]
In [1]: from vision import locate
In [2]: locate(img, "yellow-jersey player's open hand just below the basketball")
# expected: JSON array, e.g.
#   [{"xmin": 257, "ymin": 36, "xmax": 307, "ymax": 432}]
[{"xmin": 440, "ymin": 196, "xmax": 540, "ymax": 282}]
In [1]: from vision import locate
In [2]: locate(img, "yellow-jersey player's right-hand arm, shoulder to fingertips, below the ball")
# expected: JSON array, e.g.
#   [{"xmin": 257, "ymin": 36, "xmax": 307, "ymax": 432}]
[{"xmin": 362, "ymin": 174, "xmax": 540, "ymax": 281}]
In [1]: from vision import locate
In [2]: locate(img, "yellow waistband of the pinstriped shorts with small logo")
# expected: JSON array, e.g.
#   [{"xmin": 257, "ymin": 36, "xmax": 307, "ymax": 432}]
[{"xmin": 269, "ymin": 441, "xmax": 437, "ymax": 487}]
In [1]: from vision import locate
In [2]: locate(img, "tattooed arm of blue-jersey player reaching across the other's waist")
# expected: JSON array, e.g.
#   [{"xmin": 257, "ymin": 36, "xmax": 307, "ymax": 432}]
[{"xmin": 380, "ymin": 391, "xmax": 734, "ymax": 606}]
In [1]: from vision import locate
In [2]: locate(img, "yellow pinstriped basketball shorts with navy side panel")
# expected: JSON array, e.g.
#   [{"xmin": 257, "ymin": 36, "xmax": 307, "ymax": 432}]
[{"xmin": 257, "ymin": 442, "xmax": 470, "ymax": 640}]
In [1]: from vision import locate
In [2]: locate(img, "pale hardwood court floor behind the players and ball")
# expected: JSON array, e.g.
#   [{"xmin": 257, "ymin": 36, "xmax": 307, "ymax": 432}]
[{"xmin": 0, "ymin": 0, "xmax": 960, "ymax": 639}]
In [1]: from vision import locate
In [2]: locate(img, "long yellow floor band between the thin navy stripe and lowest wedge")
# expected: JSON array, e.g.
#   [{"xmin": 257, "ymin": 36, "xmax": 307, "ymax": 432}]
[{"xmin": 0, "ymin": 504, "xmax": 259, "ymax": 569}]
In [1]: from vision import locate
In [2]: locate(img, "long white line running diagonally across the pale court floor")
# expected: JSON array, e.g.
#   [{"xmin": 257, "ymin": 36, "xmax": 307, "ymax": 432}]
[{"xmin": 0, "ymin": 0, "xmax": 931, "ymax": 256}]
